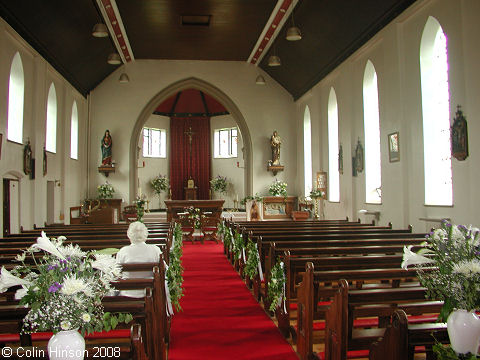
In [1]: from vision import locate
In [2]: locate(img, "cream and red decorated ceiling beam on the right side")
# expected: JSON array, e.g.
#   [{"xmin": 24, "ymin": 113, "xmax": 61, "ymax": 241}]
[{"xmin": 247, "ymin": 0, "xmax": 298, "ymax": 65}]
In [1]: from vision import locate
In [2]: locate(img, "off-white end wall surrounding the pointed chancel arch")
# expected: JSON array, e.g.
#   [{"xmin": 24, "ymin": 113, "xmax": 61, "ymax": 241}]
[{"xmin": 89, "ymin": 60, "xmax": 297, "ymax": 206}]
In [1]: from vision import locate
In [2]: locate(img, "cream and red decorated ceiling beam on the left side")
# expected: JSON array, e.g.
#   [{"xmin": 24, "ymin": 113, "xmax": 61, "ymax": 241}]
[{"xmin": 97, "ymin": 0, "xmax": 135, "ymax": 64}]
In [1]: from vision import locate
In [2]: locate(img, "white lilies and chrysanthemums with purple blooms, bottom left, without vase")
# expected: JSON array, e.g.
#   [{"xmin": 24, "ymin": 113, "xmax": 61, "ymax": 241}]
[{"xmin": 0, "ymin": 232, "xmax": 132, "ymax": 333}]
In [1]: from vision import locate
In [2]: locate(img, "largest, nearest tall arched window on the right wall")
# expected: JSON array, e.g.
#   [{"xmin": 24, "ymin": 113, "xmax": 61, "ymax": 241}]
[{"xmin": 420, "ymin": 17, "xmax": 453, "ymax": 205}]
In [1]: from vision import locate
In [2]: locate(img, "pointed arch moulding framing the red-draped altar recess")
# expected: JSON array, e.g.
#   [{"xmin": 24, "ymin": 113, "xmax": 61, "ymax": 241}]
[{"xmin": 129, "ymin": 78, "xmax": 253, "ymax": 205}]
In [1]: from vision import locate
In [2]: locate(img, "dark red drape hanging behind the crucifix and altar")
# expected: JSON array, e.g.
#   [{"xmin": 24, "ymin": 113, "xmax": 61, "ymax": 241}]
[{"xmin": 170, "ymin": 117, "xmax": 210, "ymax": 200}]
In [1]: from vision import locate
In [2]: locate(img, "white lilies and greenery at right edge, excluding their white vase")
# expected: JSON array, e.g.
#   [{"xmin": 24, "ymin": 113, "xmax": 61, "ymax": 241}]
[{"xmin": 402, "ymin": 221, "xmax": 480, "ymax": 321}]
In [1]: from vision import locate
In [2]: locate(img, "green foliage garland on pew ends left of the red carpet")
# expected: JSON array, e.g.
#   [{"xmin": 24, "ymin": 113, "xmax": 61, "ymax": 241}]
[{"xmin": 166, "ymin": 223, "xmax": 183, "ymax": 311}]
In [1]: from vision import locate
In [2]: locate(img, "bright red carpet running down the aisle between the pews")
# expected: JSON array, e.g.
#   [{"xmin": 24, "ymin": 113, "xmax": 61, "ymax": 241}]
[{"xmin": 168, "ymin": 242, "xmax": 298, "ymax": 360}]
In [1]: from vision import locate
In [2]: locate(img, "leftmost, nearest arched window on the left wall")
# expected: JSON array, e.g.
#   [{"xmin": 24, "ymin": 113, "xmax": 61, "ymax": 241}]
[{"xmin": 7, "ymin": 52, "xmax": 25, "ymax": 143}]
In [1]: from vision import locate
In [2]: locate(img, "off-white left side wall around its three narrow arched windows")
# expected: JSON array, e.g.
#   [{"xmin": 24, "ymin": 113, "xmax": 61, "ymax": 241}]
[{"xmin": 0, "ymin": 19, "xmax": 87, "ymax": 229}]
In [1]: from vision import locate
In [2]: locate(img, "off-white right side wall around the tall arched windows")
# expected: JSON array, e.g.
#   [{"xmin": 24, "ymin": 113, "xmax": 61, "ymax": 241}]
[{"xmin": 296, "ymin": 0, "xmax": 480, "ymax": 231}]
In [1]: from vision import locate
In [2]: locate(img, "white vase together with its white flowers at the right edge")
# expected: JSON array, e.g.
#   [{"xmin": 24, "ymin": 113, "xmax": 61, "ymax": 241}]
[{"xmin": 402, "ymin": 221, "xmax": 480, "ymax": 355}]
